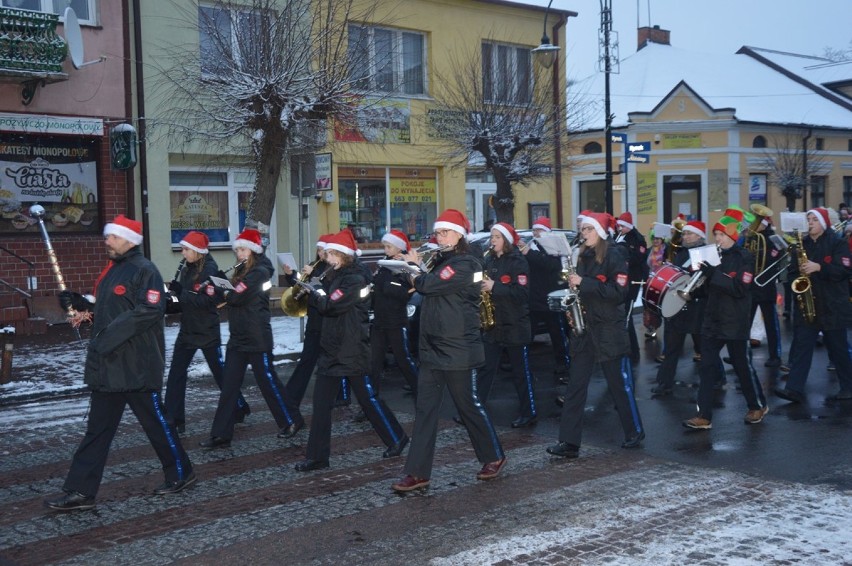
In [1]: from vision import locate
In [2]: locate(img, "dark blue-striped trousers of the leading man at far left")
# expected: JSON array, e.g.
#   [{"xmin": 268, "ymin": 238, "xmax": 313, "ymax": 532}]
[{"xmin": 63, "ymin": 391, "xmax": 192, "ymax": 497}]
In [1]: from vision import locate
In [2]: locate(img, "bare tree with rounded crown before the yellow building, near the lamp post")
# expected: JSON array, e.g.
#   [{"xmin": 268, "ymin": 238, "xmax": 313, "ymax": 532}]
[{"xmin": 425, "ymin": 35, "xmax": 564, "ymax": 223}]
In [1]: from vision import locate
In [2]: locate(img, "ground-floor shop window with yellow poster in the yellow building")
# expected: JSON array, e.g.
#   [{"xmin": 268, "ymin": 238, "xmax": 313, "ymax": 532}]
[{"xmin": 338, "ymin": 167, "xmax": 437, "ymax": 249}]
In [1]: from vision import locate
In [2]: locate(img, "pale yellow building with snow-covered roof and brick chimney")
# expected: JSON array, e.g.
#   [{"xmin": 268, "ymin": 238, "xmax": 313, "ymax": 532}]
[{"xmin": 566, "ymin": 27, "xmax": 852, "ymax": 234}]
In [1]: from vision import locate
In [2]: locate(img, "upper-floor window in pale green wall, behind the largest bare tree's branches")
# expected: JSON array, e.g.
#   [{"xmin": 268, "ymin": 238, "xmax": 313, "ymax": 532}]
[{"xmin": 198, "ymin": 5, "xmax": 270, "ymax": 78}]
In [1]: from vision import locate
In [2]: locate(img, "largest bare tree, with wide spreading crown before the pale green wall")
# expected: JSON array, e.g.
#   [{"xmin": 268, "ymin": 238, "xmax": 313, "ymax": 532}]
[{"xmin": 151, "ymin": 0, "xmax": 382, "ymax": 233}]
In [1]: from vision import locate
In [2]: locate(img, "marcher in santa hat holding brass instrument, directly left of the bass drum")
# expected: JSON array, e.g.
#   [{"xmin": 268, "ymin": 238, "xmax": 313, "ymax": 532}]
[{"xmin": 547, "ymin": 212, "xmax": 645, "ymax": 458}]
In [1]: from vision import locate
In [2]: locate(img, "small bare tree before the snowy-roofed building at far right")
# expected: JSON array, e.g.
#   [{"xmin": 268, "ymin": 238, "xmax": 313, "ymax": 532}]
[{"xmin": 763, "ymin": 129, "xmax": 825, "ymax": 212}]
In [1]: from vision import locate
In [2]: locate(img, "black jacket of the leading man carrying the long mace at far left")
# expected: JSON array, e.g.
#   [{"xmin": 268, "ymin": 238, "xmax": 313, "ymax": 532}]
[{"xmin": 84, "ymin": 246, "xmax": 166, "ymax": 392}]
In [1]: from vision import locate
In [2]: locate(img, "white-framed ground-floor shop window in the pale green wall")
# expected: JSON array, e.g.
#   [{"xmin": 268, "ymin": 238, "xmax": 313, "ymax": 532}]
[{"xmin": 169, "ymin": 169, "xmax": 254, "ymax": 249}]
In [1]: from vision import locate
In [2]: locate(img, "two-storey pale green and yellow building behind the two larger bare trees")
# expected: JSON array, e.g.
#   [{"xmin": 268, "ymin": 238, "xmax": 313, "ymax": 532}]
[{"xmin": 135, "ymin": 0, "xmax": 576, "ymax": 274}]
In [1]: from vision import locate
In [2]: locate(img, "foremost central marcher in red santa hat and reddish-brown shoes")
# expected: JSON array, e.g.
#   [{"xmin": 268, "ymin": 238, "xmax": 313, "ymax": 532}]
[{"xmin": 391, "ymin": 209, "xmax": 506, "ymax": 493}]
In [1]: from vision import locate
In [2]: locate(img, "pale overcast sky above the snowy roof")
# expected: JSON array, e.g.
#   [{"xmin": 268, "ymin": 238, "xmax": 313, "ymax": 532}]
[{"xmin": 519, "ymin": 0, "xmax": 852, "ymax": 78}]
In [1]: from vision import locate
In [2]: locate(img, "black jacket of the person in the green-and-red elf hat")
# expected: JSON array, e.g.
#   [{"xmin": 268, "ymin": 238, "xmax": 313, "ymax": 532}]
[{"xmin": 701, "ymin": 244, "xmax": 754, "ymax": 340}]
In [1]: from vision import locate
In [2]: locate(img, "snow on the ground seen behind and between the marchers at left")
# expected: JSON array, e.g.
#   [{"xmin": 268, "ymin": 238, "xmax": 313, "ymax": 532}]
[{"xmin": 0, "ymin": 316, "xmax": 302, "ymax": 403}]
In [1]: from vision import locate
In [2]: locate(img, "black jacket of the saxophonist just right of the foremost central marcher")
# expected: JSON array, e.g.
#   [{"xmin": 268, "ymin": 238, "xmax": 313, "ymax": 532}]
[{"xmin": 482, "ymin": 248, "xmax": 530, "ymax": 345}]
